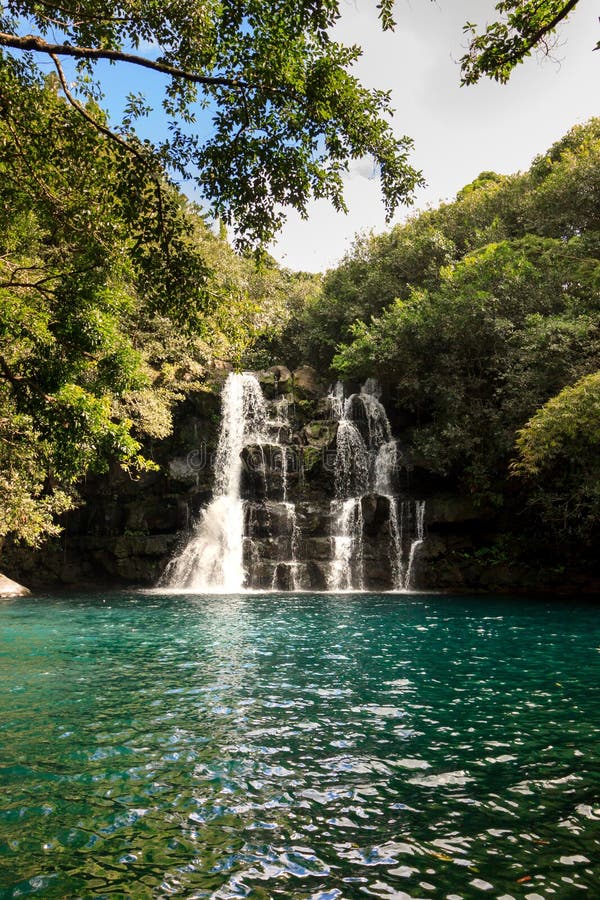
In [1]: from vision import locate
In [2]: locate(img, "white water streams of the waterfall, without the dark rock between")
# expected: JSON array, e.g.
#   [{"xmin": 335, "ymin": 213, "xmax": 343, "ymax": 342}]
[{"xmin": 159, "ymin": 373, "xmax": 425, "ymax": 593}]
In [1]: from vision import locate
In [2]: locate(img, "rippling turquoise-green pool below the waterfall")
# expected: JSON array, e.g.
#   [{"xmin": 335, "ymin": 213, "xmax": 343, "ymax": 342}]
[{"xmin": 0, "ymin": 594, "xmax": 600, "ymax": 900}]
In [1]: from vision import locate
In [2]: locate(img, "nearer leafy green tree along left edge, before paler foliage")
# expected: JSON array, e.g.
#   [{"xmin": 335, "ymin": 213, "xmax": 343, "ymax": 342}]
[{"xmin": 0, "ymin": 68, "xmax": 200, "ymax": 543}]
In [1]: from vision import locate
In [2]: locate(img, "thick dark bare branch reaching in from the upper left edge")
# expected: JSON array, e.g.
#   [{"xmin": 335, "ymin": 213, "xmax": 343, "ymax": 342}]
[{"xmin": 0, "ymin": 32, "xmax": 249, "ymax": 89}]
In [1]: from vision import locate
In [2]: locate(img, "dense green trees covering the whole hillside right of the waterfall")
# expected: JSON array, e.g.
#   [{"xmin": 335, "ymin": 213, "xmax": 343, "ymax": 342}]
[{"xmin": 281, "ymin": 120, "xmax": 600, "ymax": 556}]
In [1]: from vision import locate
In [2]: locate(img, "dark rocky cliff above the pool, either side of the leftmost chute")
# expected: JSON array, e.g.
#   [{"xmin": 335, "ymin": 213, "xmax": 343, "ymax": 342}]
[{"xmin": 3, "ymin": 366, "xmax": 600, "ymax": 591}]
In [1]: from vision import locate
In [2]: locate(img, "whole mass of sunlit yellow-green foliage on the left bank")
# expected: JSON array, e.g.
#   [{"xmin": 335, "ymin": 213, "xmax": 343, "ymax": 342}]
[{"xmin": 0, "ymin": 63, "xmax": 314, "ymax": 543}]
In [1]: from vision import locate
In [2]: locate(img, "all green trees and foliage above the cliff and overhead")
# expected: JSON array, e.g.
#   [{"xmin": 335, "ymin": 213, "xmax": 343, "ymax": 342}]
[{"xmin": 0, "ymin": 0, "xmax": 600, "ymax": 576}]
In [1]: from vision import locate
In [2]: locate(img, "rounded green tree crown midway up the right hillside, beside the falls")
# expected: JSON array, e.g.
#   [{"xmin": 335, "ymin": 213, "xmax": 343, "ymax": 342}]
[{"xmin": 334, "ymin": 236, "xmax": 600, "ymax": 491}]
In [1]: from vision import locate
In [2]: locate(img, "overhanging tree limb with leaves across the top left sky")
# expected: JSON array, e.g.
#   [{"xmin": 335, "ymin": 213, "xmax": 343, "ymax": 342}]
[{"xmin": 0, "ymin": 0, "xmax": 421, "ymax": 244}]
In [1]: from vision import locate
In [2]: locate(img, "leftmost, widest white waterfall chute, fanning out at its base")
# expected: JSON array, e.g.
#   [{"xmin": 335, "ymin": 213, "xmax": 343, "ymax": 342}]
[{"xmin": 160, "ymin": 373, "xmax": 267, "ymax": 593}]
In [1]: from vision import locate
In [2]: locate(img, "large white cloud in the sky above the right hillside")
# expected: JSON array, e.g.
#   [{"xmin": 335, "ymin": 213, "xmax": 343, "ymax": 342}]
[{"xmin": 272, "ymin": 0, "xmax": 600, "ymax": 271}]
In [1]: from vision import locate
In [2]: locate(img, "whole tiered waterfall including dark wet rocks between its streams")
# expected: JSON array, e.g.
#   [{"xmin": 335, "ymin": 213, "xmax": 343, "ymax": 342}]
[{"xmin": 159, "ymin": 373, "xmax": 424, "ymax": 593}]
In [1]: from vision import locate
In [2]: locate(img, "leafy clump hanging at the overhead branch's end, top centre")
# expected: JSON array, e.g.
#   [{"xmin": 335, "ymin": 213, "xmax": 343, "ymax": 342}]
[{"xmin": 197, "ymin": 19, "xmax": 421, "ymax": 246}]
